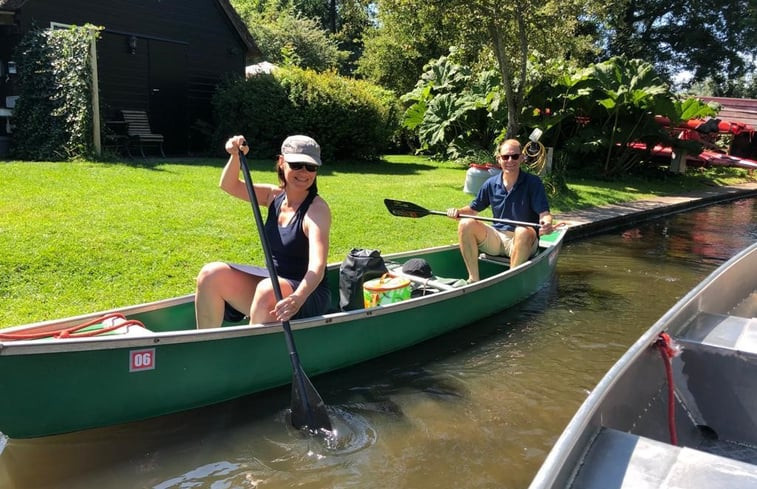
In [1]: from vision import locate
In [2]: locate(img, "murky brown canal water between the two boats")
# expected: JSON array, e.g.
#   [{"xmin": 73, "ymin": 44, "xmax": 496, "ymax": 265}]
[{"xmin": 0, "ymin": 199, "xmax": 757, "ymax": 489}]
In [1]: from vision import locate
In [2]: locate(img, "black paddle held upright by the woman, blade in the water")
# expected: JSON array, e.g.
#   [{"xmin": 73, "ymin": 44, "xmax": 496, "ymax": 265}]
[{"xmin": 239, "ymin": 143, "xmax": 333, "ymax": 435}]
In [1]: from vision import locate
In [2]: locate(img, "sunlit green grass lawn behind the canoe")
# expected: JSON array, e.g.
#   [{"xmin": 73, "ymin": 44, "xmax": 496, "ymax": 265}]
[{"xmin": 0, "ymin": 155, "xmax": 746, "ymax": 327}]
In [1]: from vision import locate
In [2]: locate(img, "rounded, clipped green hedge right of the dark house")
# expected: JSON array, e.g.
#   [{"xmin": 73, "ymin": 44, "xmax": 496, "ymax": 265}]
[{"xmin": 213, "ymin": 67, "xmax": 399, "ymax": 159}]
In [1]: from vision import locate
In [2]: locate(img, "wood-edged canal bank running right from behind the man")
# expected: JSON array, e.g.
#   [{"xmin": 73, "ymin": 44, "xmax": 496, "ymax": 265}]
[{"xmin": 555, "ymin": 182, "xmax": 757, "ymax": 241}]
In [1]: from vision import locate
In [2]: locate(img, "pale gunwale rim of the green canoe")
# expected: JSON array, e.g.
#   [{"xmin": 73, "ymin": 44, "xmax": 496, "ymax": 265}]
[{"xmin": 0, "ymin": 230, "xmax": 567, "ymax": 356}]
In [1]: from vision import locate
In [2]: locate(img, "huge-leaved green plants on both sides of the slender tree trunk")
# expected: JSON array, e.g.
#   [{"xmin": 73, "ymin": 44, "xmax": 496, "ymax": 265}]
[{"xmin": 402, "ymin": 50, "xmax": 715, "ymax": 177}]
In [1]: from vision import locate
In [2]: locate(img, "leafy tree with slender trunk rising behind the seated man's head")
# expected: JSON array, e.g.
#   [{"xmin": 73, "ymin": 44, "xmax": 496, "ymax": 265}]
[{"xmin": 360, "ymin": 0, "xmax": 605, "ymax": 137}]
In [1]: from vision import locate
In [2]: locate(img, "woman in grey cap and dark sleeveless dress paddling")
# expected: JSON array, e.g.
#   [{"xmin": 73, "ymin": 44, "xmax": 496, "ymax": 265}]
[{"xmin": 195, "ymin": 136, "xmax": 331, "ymax": 328}]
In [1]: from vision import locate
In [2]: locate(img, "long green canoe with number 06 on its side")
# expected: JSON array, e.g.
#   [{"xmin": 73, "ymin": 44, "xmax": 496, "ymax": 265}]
[{"xmin": 0, "ymin": 229, "xmax": 566, "ymax": 438}]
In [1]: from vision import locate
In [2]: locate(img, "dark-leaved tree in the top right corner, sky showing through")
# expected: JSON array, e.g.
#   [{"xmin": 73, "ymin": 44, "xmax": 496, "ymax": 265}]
[{"xmin": 605, "ymin": 0, "xmax": 757, "ymax": 85}]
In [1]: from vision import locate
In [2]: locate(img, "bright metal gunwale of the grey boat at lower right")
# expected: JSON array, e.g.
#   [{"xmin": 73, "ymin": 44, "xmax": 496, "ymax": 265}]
[{"xmin": 528, "ymin": 242, "xmax": 757, "ymax": 489}]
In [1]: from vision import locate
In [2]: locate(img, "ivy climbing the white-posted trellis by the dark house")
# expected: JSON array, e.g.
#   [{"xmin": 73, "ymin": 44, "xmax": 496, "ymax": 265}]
[{"xmin": 11, "ymin": 25, "xmax": 100, "ymax": 160}]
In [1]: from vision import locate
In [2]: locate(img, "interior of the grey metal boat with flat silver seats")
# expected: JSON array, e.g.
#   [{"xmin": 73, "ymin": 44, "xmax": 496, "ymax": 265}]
[{"xmin": 566, "ymin": 253, "xmax": 757, "ymax": 489}]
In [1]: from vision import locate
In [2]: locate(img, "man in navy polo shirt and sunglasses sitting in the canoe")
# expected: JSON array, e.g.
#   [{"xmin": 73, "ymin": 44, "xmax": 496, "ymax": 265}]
[{"xmin": 447, "ymin": 139, "xmax": 553, "ymax": 282}]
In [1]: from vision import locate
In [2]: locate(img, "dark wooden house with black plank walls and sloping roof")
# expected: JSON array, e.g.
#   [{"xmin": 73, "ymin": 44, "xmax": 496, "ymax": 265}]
[{"xmin": 0, "ymin": 0, "xmax": 260, "ymax": 155}]
